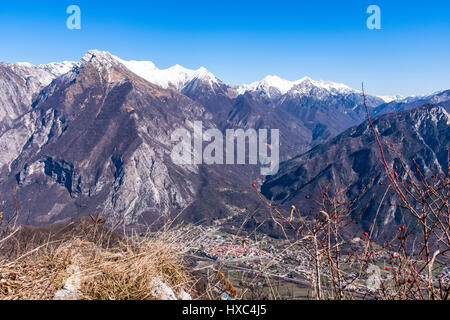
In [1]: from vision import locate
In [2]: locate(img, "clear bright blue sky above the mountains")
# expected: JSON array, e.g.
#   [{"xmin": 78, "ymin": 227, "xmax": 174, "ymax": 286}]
[{"xmin": 0, "ymin": 0, "xmax": 450, "ymax": 95}]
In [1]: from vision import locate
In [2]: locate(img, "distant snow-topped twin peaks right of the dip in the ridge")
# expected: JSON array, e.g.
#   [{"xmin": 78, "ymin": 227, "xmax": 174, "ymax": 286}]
[{"xmin": 233, "ymin": 76, "xmax": 384, "ymax": 154}]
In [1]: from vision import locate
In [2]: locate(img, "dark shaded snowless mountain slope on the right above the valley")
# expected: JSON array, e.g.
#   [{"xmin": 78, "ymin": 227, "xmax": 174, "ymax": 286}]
[{"xmin": 261, "ymin": 105, "xmax": 450, "ymax": 237}]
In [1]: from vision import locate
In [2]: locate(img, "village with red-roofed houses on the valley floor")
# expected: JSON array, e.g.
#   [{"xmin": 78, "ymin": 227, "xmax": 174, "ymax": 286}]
[{"xmin": 166, "ymin": 223, "xmax": 450, "ymax": 294}]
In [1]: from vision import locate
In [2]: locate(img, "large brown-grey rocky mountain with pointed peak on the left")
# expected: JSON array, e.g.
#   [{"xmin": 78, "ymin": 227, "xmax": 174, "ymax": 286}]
[{"xmin": 0, "ymin": 52, "xmax": 211, "ymax": 224}]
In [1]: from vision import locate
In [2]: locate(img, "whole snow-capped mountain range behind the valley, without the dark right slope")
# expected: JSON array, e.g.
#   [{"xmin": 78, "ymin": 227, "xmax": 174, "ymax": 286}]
[{"xmin": 0, "ymin": 50, "xmax": 450, "ymax": 232}]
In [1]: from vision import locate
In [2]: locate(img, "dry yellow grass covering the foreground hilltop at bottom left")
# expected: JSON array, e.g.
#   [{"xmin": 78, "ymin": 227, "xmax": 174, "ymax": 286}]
[{"xmin": 0, "ymin": 224, "xmax": 192, "ymax": 300}]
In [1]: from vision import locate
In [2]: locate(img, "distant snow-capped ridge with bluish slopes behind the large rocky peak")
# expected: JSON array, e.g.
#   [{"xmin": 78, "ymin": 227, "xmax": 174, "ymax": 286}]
[{"xmin": 96, "ymin": 56, "xmax": 384, "ymax": 160}]
